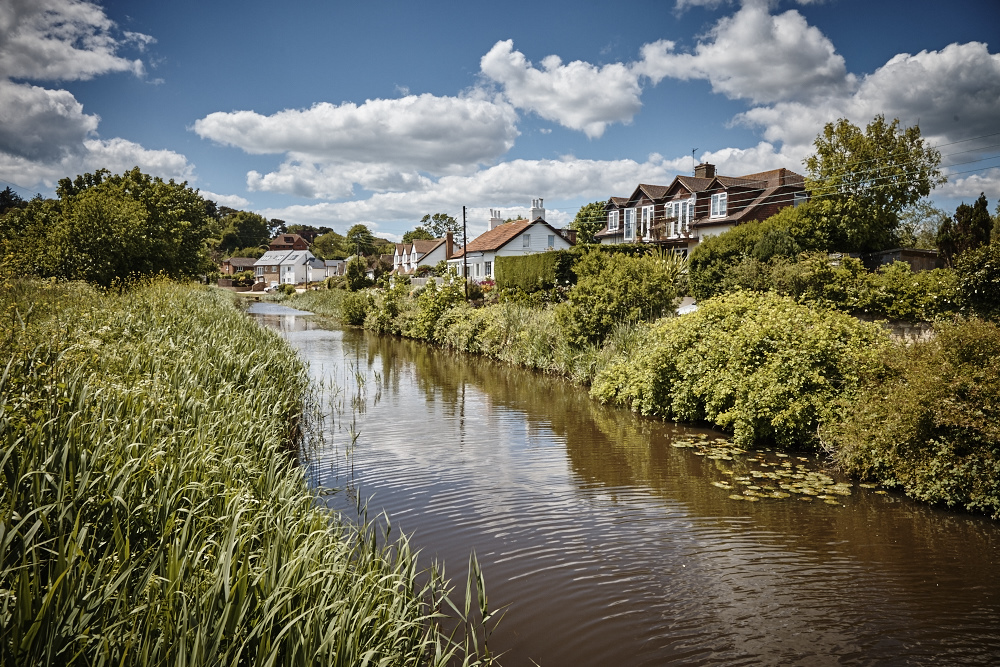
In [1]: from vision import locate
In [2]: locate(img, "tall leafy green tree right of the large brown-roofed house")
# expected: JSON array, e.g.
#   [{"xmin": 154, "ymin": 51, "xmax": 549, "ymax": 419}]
[{"xmin": 805, "ymin": 114, "xmax": 945, "ymax": 252}]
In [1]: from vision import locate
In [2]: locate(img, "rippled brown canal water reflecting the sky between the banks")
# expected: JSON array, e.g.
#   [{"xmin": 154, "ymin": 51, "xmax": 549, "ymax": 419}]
[{"xmin": 254, "ymin": 304, "xmax": 1000, "ymax": 666}]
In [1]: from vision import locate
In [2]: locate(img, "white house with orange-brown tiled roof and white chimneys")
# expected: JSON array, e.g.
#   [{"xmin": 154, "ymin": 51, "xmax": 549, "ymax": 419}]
[{"xmin": 448, "ymin": 199, "xmax": 573, "ymax": 282}]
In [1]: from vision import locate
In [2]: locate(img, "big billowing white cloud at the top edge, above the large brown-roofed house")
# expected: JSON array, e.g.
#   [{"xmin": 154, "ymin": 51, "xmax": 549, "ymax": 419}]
[{"xmin": 637, "ymin": 2, "xmax": 856, "ymax": 104}]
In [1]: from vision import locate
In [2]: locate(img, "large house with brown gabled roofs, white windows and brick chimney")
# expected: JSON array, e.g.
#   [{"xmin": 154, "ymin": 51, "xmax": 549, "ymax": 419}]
[{"xmin": 594, "ymin": 163, "xmax": 808, "ymax": 253}]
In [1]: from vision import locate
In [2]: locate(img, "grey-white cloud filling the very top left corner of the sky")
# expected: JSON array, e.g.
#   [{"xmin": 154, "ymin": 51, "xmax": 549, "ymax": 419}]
[{"xmin": 0, "ymin": 0, "xmax": 152, "ymax": 81}]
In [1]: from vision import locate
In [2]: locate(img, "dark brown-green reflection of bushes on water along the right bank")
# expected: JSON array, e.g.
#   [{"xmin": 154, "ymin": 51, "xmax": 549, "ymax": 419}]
[{"xmin": 360, "ymin": 332, "xmax": 1000, "ymax": 588}]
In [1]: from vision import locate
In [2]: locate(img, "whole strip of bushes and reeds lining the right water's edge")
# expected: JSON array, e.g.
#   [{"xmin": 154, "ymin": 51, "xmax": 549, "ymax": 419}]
[{"xmin": 294, "ymin": 284, "xmax": 1000, "ymax": 517}]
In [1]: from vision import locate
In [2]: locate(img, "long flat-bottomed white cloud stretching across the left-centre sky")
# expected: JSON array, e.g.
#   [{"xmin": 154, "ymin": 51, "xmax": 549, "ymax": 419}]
[{"xmin": 193, "ymin": 94, "xmax": 517, "ymax": 174}]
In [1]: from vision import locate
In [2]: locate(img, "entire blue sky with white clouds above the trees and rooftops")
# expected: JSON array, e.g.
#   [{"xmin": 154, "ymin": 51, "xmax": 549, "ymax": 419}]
[{"xmin": 0, "ymin": 0, "xmax": 1000, "ymax": 240}]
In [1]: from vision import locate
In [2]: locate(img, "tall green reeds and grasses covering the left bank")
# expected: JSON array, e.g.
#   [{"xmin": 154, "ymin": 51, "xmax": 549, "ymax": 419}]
[{"xmin": 0, "ymin": 282, "xmax": 490, "ymax": 665}]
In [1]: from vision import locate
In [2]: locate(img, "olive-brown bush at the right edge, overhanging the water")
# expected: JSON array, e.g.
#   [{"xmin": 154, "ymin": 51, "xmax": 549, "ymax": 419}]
[{"xmin": 821, "ymin": 319, "xmax": 1000, "ymax": 518}]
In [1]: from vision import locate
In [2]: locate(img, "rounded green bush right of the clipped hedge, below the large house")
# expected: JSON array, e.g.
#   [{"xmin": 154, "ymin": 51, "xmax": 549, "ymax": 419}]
[{"xmin": 556, "ymin": 250, "xmax": 683, "ymax": 347}]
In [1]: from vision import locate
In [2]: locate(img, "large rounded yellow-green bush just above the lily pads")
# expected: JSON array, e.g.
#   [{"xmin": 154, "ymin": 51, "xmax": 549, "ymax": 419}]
[{"xmin": 591, "ymin": 292, "xmax": 888, "ymax": 448}]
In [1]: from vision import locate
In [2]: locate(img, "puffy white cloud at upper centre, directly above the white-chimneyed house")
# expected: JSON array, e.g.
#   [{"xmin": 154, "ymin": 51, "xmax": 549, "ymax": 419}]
[{"xmin": 479, "ymin": 40, "xmax": 642, "ymax": 138}]
